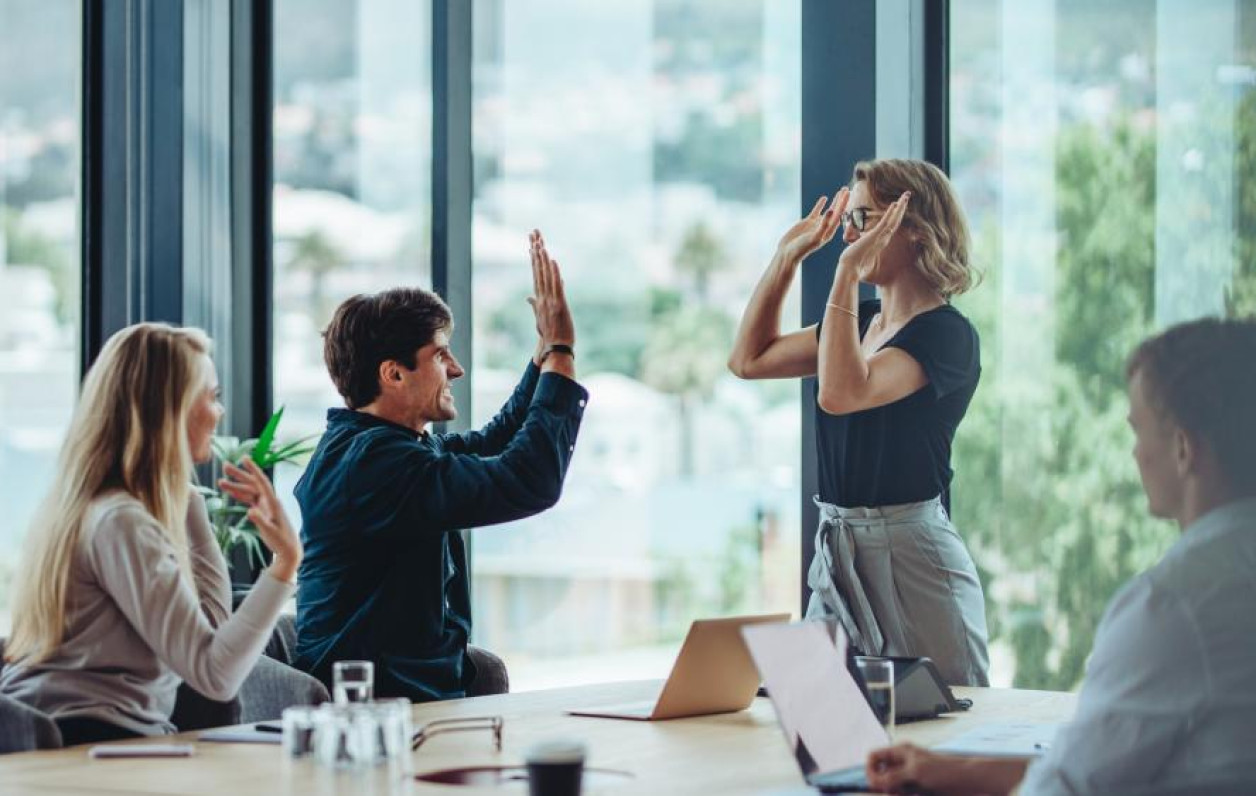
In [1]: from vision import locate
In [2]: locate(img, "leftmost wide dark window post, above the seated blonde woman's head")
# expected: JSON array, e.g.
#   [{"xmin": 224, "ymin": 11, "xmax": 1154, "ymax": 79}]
[{"xmin": 82, "ymin": 0, "xmax": 183, "ymax": 372}]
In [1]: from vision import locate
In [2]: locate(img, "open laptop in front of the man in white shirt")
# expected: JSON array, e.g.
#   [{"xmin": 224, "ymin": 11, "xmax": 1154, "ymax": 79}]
[{"xmin": 742, "ymin": 621, "xmax": 891, "ymax": 792}]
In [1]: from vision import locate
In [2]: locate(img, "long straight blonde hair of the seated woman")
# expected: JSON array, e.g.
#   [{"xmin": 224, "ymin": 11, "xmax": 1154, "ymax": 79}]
[{"xmin": 5, "ymin": 323, "xmax": 210, "ymax": 663}]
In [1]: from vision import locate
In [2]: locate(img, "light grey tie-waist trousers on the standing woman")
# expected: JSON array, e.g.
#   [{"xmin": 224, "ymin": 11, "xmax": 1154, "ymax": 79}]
[{"xmin": 806, "ymin": 497, "xmax": 990, "ymax": 686}]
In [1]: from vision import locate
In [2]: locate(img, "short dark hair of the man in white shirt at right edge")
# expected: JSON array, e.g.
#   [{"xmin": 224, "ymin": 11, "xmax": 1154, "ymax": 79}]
[{"xmin": 1125, "ymin": 318, "xmax": 1256, "ymax": 488}]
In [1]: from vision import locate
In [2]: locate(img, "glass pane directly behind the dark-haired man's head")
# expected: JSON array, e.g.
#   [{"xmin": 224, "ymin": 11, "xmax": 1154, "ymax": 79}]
[{"xmin": 272, "ymin": 0, "xmax": 432, "ymax": 507}]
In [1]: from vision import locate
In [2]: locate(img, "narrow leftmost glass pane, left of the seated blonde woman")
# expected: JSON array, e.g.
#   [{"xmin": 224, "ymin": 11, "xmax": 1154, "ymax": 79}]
[{"xmin": 0, "ymin": 0, "xmax": 82, "ymax": 635}]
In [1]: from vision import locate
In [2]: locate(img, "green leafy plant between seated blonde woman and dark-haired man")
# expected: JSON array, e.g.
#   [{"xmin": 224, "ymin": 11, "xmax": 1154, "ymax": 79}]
[{"xmin": 196, "ymin": 407, "xmax": 318, "ymax": 583}]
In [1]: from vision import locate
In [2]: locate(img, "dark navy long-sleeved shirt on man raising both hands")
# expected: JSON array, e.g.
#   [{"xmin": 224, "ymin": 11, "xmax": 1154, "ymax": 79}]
[{"xmin": 295, "ymin": 364, "xmax": 588, "ymax": 702}]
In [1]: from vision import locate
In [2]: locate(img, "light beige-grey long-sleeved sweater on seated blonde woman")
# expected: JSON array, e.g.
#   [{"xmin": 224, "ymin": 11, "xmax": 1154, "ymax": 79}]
[{"xmin": 0, "ymin": 492, "xmax": 294, "ymax": 736}]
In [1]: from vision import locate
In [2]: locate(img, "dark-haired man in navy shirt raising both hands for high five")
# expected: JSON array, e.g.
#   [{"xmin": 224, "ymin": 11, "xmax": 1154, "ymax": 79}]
[{"xmin": 295, "ymin": 231, "xmax": 588, "ymax": 702}]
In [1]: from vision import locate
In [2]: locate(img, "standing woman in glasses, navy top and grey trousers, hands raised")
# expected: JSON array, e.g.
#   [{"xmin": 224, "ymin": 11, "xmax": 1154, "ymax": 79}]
[{"xmin": 728, "ymin": 159, "xmax": 988, "ymax": 686}]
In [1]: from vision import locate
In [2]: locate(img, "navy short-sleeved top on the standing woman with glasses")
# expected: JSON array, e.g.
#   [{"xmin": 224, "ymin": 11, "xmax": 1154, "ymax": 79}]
[{"xmin": 815, "ymin": 300, "xmax": 981, "ymax": 508}]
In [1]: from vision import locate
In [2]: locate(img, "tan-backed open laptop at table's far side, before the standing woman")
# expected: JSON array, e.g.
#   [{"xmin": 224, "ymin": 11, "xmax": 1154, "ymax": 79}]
[{"xmin": 568, "ymin": 614, "xmax": 789, "ymax": 722}]
